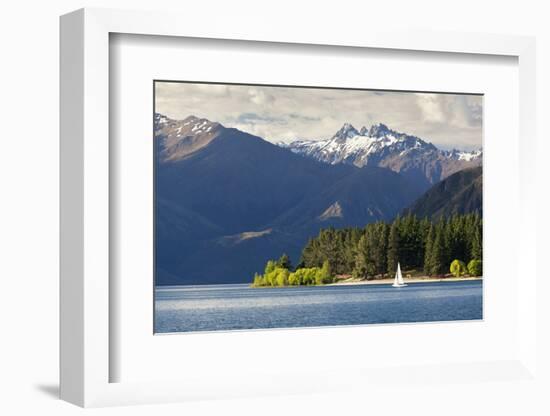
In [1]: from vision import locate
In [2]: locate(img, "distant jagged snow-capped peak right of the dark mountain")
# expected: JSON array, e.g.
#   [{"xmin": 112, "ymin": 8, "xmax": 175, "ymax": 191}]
[{"xmin": 279, "ymin": 123, "xmax": 482, "ymax": 184}]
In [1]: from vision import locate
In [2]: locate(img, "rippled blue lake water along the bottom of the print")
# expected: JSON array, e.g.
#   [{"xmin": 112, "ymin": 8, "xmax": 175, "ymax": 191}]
[{"xmin": 155, "ymin": 280, "xmax": 483, "ymax": 333}]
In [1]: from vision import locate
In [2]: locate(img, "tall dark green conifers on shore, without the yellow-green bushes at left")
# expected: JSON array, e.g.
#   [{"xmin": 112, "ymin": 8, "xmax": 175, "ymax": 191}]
[{"xmin": 299, "ymin": 214, "xmax": 483, "ymax": 278}]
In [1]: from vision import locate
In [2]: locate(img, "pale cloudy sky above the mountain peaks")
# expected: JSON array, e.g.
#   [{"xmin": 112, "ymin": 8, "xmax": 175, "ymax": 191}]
[{"xmin": 155, "ymin": 82, "xmax": 482, "ymax": 150}]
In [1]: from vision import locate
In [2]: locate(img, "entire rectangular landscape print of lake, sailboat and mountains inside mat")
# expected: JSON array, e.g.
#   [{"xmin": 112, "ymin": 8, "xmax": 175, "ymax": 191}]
[{"xmin": 152, "ymin": 81, "xmax": 483, "ymax": 333}]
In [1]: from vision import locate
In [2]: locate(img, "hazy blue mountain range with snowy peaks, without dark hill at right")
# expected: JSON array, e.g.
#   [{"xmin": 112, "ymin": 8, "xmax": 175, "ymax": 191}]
[{"xmin": 154, "ymin": 114, "xmax": 481, "ymax": 285}]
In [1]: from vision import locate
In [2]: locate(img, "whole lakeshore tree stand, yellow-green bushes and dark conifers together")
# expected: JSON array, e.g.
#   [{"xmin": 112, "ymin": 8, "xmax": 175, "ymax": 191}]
[{"xmin": 253, "ymin": 213, "xmax": 483, "ymax": 286}]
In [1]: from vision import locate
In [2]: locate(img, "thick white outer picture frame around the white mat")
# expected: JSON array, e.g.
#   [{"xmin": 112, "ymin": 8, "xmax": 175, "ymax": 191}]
[{"xmin": 60, "ymin": 9, "xmax": 537, "ymax": 407}]
